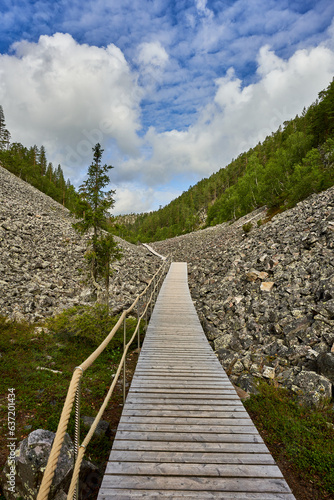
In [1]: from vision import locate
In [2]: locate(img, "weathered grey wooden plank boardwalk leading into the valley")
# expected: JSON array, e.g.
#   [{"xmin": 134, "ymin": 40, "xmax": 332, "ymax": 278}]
[{"xmin": 98, "ymin": 263, "xmax": 294, "ymax": 500}]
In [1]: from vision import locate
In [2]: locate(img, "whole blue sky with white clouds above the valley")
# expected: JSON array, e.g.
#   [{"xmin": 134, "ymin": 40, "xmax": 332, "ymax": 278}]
[{"xmin": 0, "ymin": 0, "xmax": 334, "ymax": 214}]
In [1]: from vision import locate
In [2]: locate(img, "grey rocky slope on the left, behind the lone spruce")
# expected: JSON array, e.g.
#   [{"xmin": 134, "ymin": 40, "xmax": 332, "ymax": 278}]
[{"xmin": 0, "ymin": 166, "xmax": 161, "ymax": 322}]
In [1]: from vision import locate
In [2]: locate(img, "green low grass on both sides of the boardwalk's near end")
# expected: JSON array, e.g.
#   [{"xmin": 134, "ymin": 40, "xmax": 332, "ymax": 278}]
[{"xmin": 0, "ymin": 307, "xmax": 334, "ymax": 500}]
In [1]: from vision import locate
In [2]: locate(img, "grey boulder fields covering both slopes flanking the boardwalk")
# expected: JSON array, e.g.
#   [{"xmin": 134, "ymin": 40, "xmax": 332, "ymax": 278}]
[{"xmin": 0, "ymin": 167, "xmax": 334, "ymax": 404}]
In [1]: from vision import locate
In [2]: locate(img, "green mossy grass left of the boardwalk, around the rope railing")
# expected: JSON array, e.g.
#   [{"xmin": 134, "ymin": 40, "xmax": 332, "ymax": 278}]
[{"xmin": 0, "ymin": 306, "xmax": 143, "ymax": 498}]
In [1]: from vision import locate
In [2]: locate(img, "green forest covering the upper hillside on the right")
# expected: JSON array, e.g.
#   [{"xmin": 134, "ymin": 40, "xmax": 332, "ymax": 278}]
[{"xmin": 113, "ymin": 77, "xmax": 334, "ymax": 242}]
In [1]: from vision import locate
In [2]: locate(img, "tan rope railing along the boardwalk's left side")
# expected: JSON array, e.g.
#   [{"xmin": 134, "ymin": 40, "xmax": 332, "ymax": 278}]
[{"xmin": 36, "ymin": 258, "xmax": 170, "ymax": 500}]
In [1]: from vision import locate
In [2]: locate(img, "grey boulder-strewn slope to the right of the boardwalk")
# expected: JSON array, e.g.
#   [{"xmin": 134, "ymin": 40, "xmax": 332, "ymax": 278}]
[{"xmin": 153, "ymin": 188, "xmax": 334, "ymax": 403}]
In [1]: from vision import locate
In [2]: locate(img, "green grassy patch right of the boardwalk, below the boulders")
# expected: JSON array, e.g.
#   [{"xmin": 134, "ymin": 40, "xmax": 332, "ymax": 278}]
[{"xmin": 245, "ymin": 383, "xmax": 334, "ymax": 495}]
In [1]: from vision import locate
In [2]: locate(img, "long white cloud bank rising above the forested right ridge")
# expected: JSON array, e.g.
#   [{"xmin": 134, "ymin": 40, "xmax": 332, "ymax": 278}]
[{"xmin": 116, "ymin": 40, "xmax": 334, "ymax": 195}]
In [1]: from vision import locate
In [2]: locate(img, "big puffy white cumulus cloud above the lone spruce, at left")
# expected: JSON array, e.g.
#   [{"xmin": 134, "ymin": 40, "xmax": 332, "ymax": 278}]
[{"xmin": 0, "ymin": 33, "xmax": 141, "ymax": 173}]
